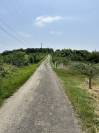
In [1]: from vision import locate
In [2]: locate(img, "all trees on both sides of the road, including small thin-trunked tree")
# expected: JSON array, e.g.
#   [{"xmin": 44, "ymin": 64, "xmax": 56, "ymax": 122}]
[{"xmin": 0, "ymin": 48, "xmax": 99, "ymax": 88}]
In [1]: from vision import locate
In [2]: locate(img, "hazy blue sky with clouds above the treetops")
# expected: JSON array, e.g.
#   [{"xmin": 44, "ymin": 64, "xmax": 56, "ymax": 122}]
[{"xmin": 0, "ymin": 0, "xmax": 99, "ymax": 52}]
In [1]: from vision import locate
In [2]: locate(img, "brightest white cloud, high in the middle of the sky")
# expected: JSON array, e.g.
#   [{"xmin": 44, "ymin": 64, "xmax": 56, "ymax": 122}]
[{"xmin": 35, "ymin": 16, "xmax": 64, "ymax": 27}]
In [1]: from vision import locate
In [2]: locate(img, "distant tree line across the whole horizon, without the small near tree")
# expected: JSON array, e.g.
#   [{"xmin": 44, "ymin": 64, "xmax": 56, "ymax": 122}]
[{"xmin": 0, "ymin": 48, "xmax": 99, "ymax": 66}]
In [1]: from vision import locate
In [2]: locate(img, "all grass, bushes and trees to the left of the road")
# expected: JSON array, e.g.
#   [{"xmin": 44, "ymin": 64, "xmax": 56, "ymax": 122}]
[{"xmin": 0, "ymin": 49, "xmax": 53, "ymax": 105}]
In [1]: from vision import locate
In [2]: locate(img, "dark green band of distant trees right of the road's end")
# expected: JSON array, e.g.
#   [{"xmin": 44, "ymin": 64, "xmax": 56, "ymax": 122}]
[{"xmin": 53, "ymin": 49, "xmax": 99, "ymax": 63}]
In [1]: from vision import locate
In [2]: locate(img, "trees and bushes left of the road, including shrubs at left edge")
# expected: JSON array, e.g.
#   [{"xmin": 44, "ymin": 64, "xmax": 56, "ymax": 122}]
[{"xmin": 0, "ymin": 48, "xmax": 53, "ymax": 77}]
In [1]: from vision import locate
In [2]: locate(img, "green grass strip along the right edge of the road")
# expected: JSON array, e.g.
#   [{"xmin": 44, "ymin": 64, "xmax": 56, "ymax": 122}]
[{"xmin": 55, "ymin": 69, "xmax": 99, "ymax": 133}]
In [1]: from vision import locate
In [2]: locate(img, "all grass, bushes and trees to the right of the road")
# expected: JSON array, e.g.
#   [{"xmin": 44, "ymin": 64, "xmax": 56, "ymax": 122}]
[{"xmin": 52, "ymin": 49, "xmax": 99, "ymax": 133}]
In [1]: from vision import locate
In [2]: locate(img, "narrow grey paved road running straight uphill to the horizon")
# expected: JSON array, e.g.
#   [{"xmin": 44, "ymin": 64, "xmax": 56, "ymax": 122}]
[{"xmin": 0, "ymin": 58, "xmax": 81, "ymax": 133}]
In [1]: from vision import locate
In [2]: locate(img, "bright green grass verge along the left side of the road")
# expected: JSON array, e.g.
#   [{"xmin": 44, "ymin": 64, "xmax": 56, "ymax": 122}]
[{"xmin": 0, "ymin": 64, "xmax": 38, "ymax": 105}]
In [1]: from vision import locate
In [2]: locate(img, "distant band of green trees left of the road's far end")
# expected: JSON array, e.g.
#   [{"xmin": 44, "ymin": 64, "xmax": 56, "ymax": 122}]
[{"xmin": 0, "ymin": 48, "xmax": 53, "ymax": 66}]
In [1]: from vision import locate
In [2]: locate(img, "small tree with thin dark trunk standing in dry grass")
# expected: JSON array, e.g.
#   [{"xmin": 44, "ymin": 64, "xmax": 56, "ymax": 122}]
[{"xmin": 76, "ymin": 63, "xmax": 99, "ymax": 89}]
